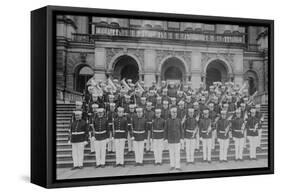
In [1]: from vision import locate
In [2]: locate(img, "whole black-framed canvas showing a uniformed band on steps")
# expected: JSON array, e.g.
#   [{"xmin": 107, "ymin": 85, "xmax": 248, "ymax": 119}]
[{"xmin": 31, "ymin": 6, "xmax": 274, "ymax": 188}]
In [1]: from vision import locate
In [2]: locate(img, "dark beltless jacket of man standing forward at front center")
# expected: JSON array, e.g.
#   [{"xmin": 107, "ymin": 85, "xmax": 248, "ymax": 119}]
[{"xmin": 165, "ymin": 118, "xmax": 183, "ymax": 143}]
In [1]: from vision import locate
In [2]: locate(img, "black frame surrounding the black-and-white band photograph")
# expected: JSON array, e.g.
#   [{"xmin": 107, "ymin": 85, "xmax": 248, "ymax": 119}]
[{"xmin": 31, "ymin": 6, "xmax": 274, "ymax": 188}]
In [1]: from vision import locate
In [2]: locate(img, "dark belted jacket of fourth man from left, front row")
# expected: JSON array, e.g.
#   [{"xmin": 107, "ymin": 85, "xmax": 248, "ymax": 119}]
[{"xmin": 133, "ymin": 116, "xmax": 147, "ymax": 141}]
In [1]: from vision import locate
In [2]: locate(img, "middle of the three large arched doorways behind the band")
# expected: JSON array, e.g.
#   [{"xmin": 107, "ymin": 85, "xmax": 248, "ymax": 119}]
[{"xmin": 161, "ymin": 57, "xmax": 186, "ymax": 81}]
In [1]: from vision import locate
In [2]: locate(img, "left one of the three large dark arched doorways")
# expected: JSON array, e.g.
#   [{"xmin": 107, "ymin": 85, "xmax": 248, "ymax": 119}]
[{"xmin": 113, "ymin": 55, "xmax": 139, "ymax": 82}]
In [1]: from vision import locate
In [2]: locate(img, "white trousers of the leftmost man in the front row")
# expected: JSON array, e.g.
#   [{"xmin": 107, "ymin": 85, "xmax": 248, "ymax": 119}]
[{"xmin": 71, "ymin": 142, "xmax": 84, "ymax": 167}]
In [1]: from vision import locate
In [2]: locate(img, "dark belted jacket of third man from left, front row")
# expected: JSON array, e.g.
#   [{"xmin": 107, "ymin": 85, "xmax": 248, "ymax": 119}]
[{"xmin": 113, "ymin": 116, "xmax": 128, "ymax": 139}]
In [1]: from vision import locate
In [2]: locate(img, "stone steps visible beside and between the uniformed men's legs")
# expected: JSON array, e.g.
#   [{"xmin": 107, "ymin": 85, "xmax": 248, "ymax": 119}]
[{"xmin": 56, "ymin": 103, "xmax": 268, "ymax": 168}]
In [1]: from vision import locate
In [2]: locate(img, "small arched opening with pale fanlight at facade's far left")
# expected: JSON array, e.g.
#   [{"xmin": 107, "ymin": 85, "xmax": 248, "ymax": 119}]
[{"xmin": 74, "ymin": 65, "xmax": 94, "ymax": 93}]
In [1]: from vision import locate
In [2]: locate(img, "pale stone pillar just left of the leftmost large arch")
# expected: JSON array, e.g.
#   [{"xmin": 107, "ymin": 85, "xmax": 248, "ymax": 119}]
[{"xmin": 94, "ymin": 48, "xmax": 106, "ymax": 81}]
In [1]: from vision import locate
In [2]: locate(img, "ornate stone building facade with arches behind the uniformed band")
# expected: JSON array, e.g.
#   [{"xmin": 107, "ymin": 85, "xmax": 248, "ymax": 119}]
[{"xmin": 56, "ymin": 15, "xmax": 268, "ymax": 100}]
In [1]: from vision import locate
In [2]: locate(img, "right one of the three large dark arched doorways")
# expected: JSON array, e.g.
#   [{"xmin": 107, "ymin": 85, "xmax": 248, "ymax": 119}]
[{"xmin": 205, "ymin": 60, "xmax": 228, "ymax": 88}]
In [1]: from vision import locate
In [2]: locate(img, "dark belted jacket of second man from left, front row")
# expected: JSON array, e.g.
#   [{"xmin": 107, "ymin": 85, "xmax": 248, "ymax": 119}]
[{"xmin": 93, "ymin": 117, "xmax": 109, "ymax": 141}]
